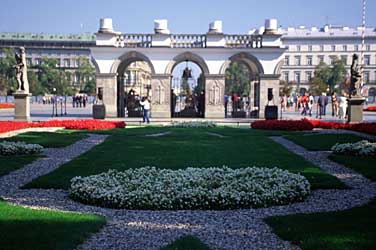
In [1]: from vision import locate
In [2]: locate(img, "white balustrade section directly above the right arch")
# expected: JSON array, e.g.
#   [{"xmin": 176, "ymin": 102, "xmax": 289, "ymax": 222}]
[{"xmin": 225, "ymin": 35, "xmax": 262, "ymax": 49}]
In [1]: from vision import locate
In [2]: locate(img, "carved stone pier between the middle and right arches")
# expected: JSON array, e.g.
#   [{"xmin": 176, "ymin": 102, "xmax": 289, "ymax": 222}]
[{"xmin": 205, "ymin": 75, "xmax": 225, "ymax": 118}]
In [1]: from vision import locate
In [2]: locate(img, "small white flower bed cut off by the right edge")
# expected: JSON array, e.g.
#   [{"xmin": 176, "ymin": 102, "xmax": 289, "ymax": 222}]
[{"xmin": 332, "ymin": 140, "xmax": 376, "ymax": 156}]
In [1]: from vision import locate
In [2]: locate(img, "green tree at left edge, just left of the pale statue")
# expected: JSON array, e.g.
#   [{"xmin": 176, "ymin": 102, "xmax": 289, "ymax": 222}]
[{"xmin": 0, "ymin": 48, "xmax": 17, "ymax": 94}]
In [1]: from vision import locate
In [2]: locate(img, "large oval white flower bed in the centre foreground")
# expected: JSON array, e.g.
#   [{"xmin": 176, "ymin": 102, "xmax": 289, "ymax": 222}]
[{"xmin": 70, "ymin": 167, "xmax": 310, "ymax": 210}]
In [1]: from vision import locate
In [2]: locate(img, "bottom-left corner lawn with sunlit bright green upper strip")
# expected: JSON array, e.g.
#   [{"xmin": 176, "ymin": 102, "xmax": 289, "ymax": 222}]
[{"xmin": 0, "ymin": 200, "xmax": 105, "ymax": 250}]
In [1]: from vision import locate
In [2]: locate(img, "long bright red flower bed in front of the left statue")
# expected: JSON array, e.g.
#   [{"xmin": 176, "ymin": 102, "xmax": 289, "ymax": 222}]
[{"xmin": 0, "ymin": 119, "xmax": 126, "ymax": 133}]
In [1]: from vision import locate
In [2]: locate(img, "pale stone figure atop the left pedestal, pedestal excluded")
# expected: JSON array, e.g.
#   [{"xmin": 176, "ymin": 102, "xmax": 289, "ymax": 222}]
[{"xmin": 14, "ymin": 47, "xmax": 29, "ymax": 94}]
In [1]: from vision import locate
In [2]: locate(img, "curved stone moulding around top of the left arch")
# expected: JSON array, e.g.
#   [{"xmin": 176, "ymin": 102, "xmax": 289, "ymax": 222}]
[{"xmin": 111, "ymin": 51, "xmax": 155, "ymax": 75}]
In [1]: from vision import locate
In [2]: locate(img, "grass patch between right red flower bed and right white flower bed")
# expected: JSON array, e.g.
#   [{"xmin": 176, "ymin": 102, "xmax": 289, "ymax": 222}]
[{"xmin": 285, "ymin": 133, "xmax": 364, "ymax": 151}]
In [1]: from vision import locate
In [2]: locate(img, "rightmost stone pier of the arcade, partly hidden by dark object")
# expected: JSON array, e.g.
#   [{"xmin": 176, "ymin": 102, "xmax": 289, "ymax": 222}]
[{"xmin": 259, "ymin": 74, "xmax": 280, "ymax": 119}]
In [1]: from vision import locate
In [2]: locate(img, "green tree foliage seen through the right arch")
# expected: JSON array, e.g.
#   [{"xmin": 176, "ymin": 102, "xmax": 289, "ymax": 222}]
[{"xmin": 225, "ymin": 62, "xmax": 250, "ymax": 96}]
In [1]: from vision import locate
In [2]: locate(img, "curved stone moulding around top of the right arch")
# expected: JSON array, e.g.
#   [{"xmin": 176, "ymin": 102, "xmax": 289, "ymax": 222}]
[{"xmin": 219, "ymin": 52, "xmax": 264, "ymax": 75}]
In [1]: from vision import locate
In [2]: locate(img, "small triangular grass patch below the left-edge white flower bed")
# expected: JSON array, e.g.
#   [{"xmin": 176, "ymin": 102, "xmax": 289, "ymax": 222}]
[{"xmin": 0, "ymin": 155, "xmax": 41, "ymax": 176}]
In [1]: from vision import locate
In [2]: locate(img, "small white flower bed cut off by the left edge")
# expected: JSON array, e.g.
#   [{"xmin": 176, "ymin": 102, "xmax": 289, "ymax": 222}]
[{"xmin": 0, "ymin": 141, "xmax": 43, "ymax": 155}]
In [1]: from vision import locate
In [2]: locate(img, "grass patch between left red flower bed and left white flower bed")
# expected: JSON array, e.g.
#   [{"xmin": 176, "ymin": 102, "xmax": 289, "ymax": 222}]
[{"xmin": 3, "ymin": 130, "xmax": 86, "ymax": 148}]
